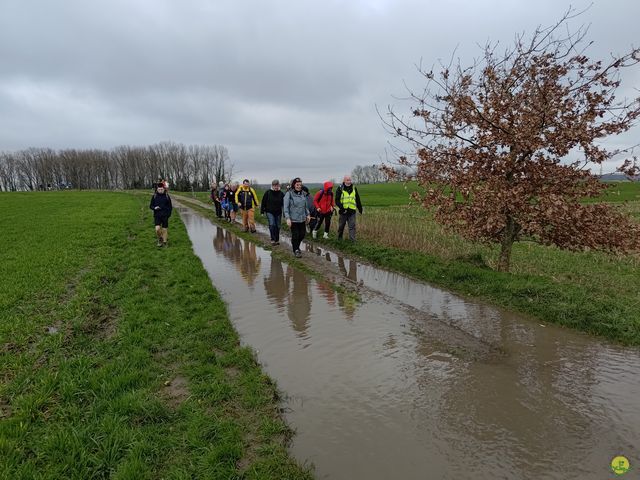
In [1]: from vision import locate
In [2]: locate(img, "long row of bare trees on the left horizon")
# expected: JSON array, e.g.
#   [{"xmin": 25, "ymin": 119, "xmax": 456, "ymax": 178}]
[{"xmin": 0, "ymin": 142, "xmax": 233, "ymax": 191}]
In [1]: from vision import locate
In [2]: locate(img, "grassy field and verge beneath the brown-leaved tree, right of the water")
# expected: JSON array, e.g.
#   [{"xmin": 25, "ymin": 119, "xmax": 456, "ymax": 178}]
[{"xmin": 181, "ymin": 182, "xmax": 640, "ymax": 345}]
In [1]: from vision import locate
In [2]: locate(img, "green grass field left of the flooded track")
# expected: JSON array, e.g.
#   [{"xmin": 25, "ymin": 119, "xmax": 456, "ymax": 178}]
[{"xmin": 0, "ymin": 192, "xmax": 311, "ymax": 480}]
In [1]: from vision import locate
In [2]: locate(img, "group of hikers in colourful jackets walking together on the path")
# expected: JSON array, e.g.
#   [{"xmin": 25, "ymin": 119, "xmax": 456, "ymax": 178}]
[{"xmin": 210, "ymin": 175, "xmax": 362, "ymax": 257}]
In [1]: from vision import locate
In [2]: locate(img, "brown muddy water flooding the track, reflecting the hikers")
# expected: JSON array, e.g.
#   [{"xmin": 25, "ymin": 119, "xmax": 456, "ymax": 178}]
[{"xmin": 180, "ymin": 209, "xmax": 640, "ymax": 480}]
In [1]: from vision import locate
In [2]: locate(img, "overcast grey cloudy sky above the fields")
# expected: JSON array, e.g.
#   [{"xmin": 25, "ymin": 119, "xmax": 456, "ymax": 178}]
[{"xmin": 0, "ymin": 0, "xmax": 640, "ymax": 182}]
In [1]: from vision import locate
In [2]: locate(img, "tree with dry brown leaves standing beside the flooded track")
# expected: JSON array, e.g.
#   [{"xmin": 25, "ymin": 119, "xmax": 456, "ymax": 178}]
[{"xmin": 386, "ymin": 10, "xmax": 640, "ymax": 271}]
